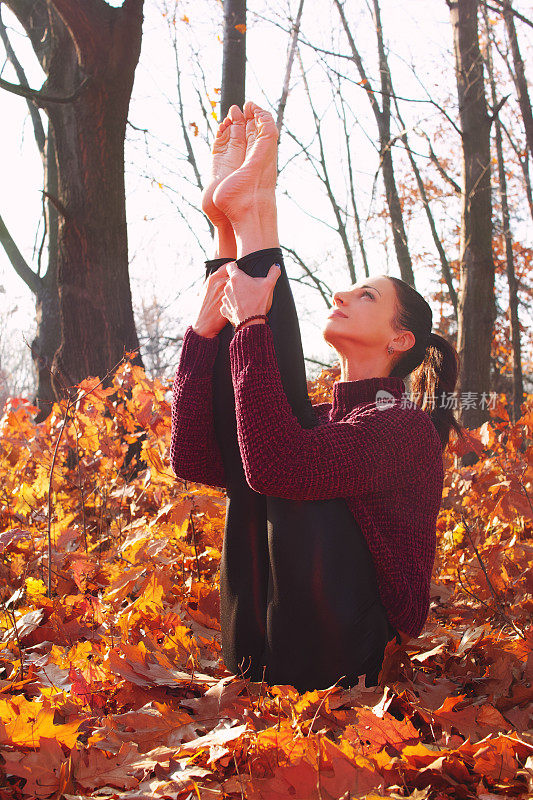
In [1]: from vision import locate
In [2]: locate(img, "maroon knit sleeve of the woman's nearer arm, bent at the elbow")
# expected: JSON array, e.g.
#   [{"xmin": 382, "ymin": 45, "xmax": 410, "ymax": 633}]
[{"xmin": 229, "ymin": 324, "xmax": 436, "ymax": 500}]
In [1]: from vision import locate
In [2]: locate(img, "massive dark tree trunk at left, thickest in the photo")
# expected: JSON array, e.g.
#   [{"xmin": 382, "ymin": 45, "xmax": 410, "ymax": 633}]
[{"xmin": 47, "ymin": 0, "xmax": 143, "ymax": 393}]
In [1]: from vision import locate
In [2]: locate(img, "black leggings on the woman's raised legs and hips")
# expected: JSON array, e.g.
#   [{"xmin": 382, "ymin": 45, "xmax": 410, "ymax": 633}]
[{"xmin": 206, "ymin": 248, "xmax": 400, "ymax": 692}]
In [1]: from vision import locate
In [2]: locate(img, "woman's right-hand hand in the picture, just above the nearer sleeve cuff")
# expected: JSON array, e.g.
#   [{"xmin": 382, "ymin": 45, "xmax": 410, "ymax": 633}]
[{"xmin": 220, "ymin": 262, "xmax": 281, "ymax": 327}]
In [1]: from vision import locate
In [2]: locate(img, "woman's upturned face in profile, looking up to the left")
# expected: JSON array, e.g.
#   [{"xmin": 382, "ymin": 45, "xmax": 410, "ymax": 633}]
[{"xmin": 322, "ymin": 275, "xmax": 398, "ymax": 355}]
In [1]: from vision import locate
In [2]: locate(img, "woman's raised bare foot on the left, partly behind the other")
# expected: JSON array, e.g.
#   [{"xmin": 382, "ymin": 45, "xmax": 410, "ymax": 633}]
[{"xmin": 202, "ymin": 106, "xmax": 246, "ymax": 227}]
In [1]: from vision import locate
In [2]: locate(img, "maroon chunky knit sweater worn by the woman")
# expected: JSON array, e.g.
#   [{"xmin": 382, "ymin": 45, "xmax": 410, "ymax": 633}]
[{"xmin": 170, "ymin": 324, "xmax": 444, "ymax": 637}]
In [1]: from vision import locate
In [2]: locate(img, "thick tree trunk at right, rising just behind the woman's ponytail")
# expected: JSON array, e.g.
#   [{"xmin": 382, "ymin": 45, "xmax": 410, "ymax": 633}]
[{"xmin": 448, "ymin": 0, "xmax": 496, "ymax": 444}]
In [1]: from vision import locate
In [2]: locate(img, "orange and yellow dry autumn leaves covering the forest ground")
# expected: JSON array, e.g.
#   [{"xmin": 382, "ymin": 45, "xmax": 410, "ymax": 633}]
[{"xmin": 0, "ymin": 363, "xmax": 533, "ymax": 800}]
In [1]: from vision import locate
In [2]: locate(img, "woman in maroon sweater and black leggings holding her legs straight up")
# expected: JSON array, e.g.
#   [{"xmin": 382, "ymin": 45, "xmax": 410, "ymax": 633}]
[{"xmin": 171, "ymin": 102, "xmax": 459, "ymax": 691}]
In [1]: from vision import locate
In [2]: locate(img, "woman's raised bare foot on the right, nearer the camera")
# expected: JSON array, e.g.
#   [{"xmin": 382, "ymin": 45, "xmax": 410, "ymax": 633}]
[{"xmin": 213, "ymin": 100, "xmax": 279, "ymax": 225}]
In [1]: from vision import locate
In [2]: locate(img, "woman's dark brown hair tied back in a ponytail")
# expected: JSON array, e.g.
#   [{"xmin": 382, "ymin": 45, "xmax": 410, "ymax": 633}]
[{"xmin": 387, "ymin": 275, "xmax": 464, "ymax": 450}]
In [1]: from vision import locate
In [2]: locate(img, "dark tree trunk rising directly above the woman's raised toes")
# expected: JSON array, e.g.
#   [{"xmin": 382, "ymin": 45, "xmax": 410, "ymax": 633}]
[{"xmin": 220, "ymin": 0, "xmax": 246, "ymax": 122}]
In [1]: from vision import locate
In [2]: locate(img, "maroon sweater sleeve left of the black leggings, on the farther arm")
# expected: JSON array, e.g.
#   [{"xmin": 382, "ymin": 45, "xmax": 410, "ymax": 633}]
[{"xmin": 170, "ymin": 325, "xmax": 226, "ymax": 488}]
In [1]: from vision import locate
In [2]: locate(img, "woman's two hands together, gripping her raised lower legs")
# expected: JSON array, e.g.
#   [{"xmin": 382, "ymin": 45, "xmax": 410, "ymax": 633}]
[{"xmin": 192, "ymin": 261, "xmax": 281, "ymax": 339}]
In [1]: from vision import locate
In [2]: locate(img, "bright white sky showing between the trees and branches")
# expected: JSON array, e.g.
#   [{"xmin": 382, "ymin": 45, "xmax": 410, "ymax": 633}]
[{"xmin": 0, "ymin": 0, "xmax": 531, "ymax": 394}]
